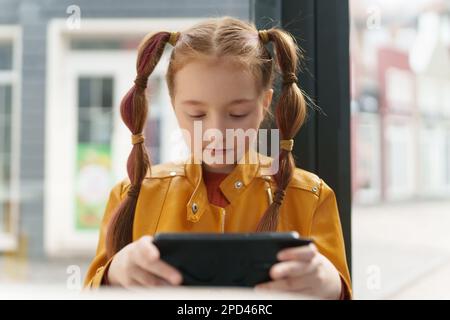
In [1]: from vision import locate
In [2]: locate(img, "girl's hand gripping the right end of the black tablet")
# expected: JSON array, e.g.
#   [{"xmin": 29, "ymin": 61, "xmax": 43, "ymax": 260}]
[{"xmin": 255, "ymin": 244, "xmax": 342, "ymax": 299}]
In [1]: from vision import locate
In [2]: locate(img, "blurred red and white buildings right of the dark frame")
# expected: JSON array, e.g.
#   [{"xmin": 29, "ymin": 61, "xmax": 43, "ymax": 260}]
[{"xmin": 351, "ymin": 1, "xmax": 450, "ymax": 204}]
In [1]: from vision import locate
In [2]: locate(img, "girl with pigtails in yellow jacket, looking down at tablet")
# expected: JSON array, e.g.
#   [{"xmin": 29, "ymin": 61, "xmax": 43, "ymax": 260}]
[{"xmin": 85, "ymin": 17, "xmax": 352, "ymax": 299}]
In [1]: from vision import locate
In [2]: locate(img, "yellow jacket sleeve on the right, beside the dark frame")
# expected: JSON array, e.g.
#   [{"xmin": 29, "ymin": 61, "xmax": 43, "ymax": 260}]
[{"xmin": 310, "ymin": 179, "xmax": 352, "ymax": 299}]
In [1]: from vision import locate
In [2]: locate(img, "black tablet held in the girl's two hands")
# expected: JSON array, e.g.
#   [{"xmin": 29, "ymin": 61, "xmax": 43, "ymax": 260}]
[{"xmin": 153, "ymin": 232, "xmax": 312, "ymax": 287}]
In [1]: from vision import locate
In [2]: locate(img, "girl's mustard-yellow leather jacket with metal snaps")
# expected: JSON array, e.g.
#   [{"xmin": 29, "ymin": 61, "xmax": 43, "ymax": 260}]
[{"xmin": 84, "ymin": 149, "xmax": 352, "ymax": 297}]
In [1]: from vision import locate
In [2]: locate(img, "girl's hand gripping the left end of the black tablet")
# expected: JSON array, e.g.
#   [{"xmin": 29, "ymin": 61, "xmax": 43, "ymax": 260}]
[{"xmin": 105, "ymin": 236, "xmax": 182, "ymax": 287}]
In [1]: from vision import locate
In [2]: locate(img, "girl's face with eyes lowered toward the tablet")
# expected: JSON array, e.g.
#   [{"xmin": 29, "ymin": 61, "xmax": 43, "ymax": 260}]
[{"xmin": 172, "ymin": 58, "xmax": 273, "ymax": 172}]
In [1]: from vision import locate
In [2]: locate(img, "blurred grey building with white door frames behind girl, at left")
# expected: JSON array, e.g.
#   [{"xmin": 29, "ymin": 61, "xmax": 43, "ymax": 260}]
[{"xmin": 0, "ymin": 0, "xmax": 253, "ymax": 282}]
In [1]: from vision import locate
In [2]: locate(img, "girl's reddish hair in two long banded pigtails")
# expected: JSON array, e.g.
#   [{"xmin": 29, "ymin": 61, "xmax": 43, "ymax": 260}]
[{"xmin": 106, "ymin": 17, "xmax": 306, "ymax": 257}]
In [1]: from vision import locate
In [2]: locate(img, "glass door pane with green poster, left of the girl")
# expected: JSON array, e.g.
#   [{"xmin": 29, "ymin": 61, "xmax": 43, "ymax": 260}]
[{"xmin": 75, "ymin": 76, "xmax": 114, "ymax": 230}]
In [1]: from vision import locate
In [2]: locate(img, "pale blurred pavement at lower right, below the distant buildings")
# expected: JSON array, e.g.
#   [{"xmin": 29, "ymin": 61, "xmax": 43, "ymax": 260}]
[{"xmin": 352, "ymin": 201, "xmax": 450, "ymax": 299}]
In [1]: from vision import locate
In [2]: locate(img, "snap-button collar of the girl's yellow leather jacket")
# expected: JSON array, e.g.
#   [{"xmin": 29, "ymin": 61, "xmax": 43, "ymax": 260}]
[{"xmin": 185, "ymin": 148, "xmax": 271, "ymax": 222}]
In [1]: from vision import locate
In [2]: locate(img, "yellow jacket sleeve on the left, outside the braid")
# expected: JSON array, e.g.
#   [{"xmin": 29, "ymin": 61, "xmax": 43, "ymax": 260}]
[{"xmin": 84, "ymin": 182, "xmax": 123, "ymax": 289}]
